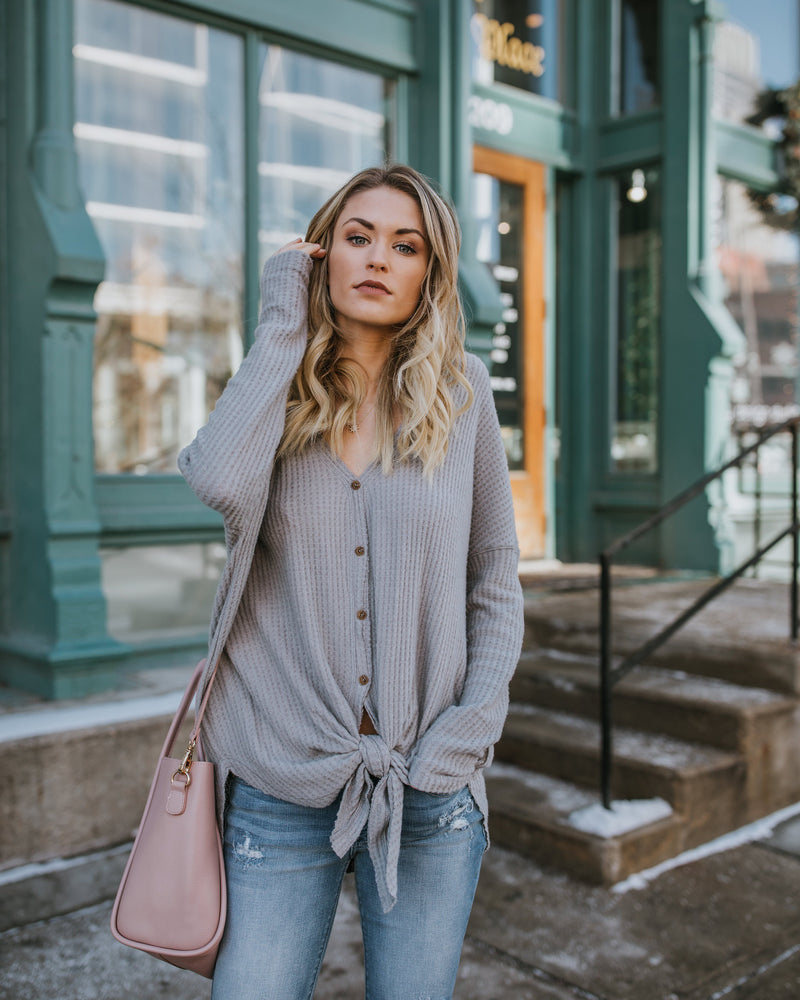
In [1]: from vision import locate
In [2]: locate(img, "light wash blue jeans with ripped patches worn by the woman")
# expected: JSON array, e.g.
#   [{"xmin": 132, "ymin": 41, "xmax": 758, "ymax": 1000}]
[{"xmin": 212, "ymin": 778, "xmax": 486, "ymax": 1000}]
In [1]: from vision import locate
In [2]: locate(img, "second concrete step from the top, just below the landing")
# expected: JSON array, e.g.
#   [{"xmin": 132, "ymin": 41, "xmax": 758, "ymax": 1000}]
[{"xmin": 511, "ymin": 649, "xmax": 797, "ymax": 754}]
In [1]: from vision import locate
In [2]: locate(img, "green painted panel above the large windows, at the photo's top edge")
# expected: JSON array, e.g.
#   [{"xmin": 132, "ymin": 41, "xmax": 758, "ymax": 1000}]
[{"xmin": 175, "ymin": 0, "xmax": 417, "ymax": 71}]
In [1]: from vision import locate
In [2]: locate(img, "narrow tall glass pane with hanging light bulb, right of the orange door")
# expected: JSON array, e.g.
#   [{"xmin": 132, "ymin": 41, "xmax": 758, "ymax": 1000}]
[{"xmin": 611, "ymin": 170, "xmax": 661, "ymax": 473}]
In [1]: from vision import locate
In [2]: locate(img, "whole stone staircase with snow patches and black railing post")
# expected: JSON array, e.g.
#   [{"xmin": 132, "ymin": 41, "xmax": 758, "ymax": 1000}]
[{"xmin": 487, "ymin": 579, "xmax": 800, "ymax": 884}]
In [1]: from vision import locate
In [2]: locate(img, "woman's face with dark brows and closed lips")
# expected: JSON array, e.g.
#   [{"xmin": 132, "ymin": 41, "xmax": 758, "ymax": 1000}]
[{"xmin": 328, "ymin": 187, "xmax": 430, "ymax": 340}]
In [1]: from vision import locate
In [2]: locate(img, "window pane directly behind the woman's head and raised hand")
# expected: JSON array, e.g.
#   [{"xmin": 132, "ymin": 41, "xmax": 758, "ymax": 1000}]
[{"xmin": 258, "ymin": 45, "xmax": 392, "ymax": 262}]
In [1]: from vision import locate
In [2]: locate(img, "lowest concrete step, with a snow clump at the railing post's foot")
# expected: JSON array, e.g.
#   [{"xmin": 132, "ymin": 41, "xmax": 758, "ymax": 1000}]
[{"xmin": 486, "ymin": 764, "xmax": 686, "ymax": 885}]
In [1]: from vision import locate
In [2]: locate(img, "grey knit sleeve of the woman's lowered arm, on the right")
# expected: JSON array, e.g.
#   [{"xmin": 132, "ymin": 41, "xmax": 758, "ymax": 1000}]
[{"xmin": 409, "ymin": 356, "xmax": 523, "ymax": 792}]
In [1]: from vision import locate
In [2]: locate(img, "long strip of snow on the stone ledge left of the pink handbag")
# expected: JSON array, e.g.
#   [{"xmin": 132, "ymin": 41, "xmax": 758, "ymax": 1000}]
[{"xmin": 0, "ymin": 691, "xmax": 183, "ymax": 743}]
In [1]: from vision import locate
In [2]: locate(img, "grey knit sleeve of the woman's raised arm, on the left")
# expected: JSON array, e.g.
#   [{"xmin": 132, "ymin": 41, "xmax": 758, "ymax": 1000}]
[{"xmin": 178, "ymin": 250, "xmax": 313, "ymax": 542}]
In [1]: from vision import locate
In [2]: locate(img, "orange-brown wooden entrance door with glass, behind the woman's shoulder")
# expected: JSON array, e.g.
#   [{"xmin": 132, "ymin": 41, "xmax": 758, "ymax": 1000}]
[{"xmin": 473, "ymin": 146, "xmax": 546, "ymax": 559}]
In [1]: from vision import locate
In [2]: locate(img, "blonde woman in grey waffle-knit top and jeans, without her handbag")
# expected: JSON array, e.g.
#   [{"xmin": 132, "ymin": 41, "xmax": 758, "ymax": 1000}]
[{"xmin": 179, "ymin": 166, "xmax": 522, "ymax": 1000}]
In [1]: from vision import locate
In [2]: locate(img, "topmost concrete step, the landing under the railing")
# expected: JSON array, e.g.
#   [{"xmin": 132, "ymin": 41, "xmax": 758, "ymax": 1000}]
[{"xmin": 525, "ymin": 580, "xmax": 800, "ymax": 694}]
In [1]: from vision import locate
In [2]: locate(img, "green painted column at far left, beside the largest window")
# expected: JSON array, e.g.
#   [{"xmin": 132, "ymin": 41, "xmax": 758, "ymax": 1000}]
[{"xmin": 0, "ymin": 0, "xmax": 126, "ymax": 698}]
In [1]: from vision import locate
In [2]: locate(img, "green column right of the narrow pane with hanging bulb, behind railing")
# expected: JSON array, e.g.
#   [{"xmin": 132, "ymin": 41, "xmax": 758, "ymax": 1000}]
[{"xmin": 659, "ymin": 0, "xmax": 741, "ymax": 570}]
